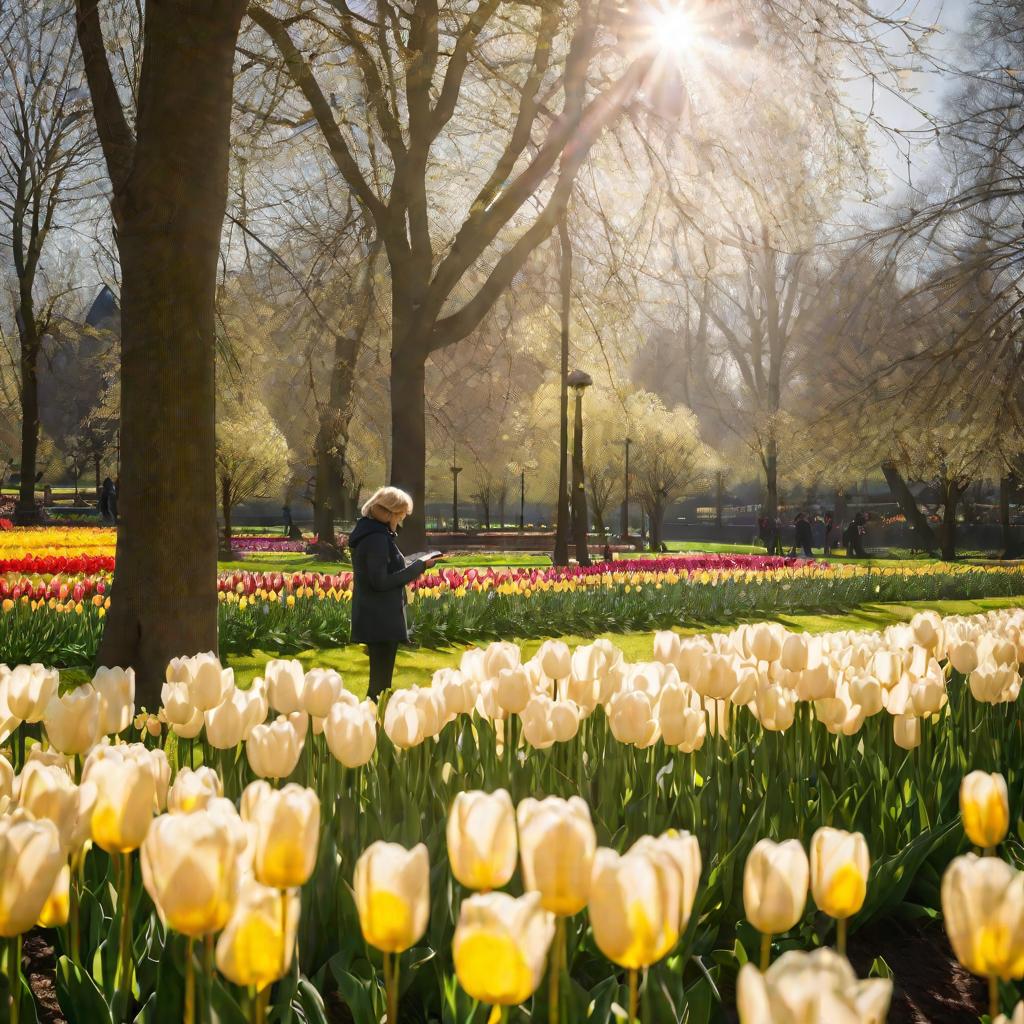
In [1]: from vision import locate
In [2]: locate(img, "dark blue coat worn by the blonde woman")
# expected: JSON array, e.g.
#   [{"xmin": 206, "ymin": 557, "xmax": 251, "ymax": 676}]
[{"xmin": 348, "ymin": 516, "xmax": 426, "ymax": 643}]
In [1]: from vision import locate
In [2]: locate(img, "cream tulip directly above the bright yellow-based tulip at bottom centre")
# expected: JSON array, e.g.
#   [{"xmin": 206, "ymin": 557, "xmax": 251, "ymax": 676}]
[{"xmin": 446, "ymin": 790, "xmax": 517, "ymax": 891}]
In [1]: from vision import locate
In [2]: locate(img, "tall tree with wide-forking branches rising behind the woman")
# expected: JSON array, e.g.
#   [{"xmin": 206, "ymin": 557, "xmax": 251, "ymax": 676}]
[{"xmin": 244, "ymin": 0, "xmax": 688, "ymax": 546}]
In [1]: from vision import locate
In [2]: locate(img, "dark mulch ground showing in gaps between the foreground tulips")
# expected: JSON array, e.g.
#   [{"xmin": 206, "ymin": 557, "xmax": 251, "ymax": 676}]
[{"xmin": 22, "ymin": 920, "xmax": 986, "ymax": 1024}]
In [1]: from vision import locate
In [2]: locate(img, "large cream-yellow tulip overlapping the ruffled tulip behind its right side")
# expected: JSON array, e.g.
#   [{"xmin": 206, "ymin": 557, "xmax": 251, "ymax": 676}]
[{"xmin": 590, "ymin": 847, "xmax": 682, "ymax": 971}]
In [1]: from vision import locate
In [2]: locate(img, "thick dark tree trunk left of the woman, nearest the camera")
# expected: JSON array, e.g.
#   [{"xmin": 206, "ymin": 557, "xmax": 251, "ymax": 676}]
[{"xmin": 76, "ymin": 0, "xmax": 246, "ymax": 707}]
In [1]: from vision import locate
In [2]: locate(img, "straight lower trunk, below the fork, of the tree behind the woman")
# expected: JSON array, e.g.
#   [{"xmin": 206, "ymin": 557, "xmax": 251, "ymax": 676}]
[{"xmin": 391, "ymin": 344, "xmax": 427, "ymax": 551}]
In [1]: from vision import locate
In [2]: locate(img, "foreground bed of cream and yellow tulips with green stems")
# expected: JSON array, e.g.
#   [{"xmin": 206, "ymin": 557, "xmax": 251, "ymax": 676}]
[{"xmin": 0, "ymin": 608, "xmax": 1024, "ymax": 1024}]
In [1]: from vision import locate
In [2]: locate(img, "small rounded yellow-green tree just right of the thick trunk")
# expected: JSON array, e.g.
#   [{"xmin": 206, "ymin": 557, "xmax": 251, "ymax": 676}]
[{"xmin": 217, "ymin": 394, "xmax": 289, "ymax": 558}]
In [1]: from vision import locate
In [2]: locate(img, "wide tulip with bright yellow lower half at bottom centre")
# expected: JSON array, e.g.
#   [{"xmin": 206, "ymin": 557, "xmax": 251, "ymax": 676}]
[{"xmin": 452, "ymin": 893, "xmax": 555, "ymax": 1007}]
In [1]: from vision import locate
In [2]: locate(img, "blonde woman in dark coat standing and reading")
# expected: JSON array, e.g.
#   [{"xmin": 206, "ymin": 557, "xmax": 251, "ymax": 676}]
[{"xmin": 348, "ymin": 487, "xmax": 434, "ymax": 700}]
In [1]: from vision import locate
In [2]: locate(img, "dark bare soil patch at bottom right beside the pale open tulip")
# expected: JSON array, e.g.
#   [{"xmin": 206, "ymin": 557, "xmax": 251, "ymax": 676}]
[{"xmin": 848, "ymin": 920, "xmax": 987, "ymax": 1024}]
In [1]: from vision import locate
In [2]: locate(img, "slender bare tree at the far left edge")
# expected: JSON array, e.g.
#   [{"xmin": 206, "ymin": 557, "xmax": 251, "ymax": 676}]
[{"xmin": 0, "ymin": 0, "xmax": 95, "ymax": 523}]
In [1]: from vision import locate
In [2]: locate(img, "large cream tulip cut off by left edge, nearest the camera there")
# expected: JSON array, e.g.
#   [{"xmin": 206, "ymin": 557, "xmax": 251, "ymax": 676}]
[{"xmin": 0, "ymin": 810, "xmax": 65, "ymax": 939}]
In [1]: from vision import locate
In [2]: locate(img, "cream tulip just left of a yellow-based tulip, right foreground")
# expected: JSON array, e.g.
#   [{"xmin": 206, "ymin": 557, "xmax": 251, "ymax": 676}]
[{"xmin": 743, "ymin": 839, "xmax": 810, "ymax": 935}]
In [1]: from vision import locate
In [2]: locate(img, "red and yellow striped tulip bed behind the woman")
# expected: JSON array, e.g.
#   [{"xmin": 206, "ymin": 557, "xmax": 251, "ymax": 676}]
[{"xmin": 0, "ymin": 527, "xmax": 1024, "ymax": 667}]
